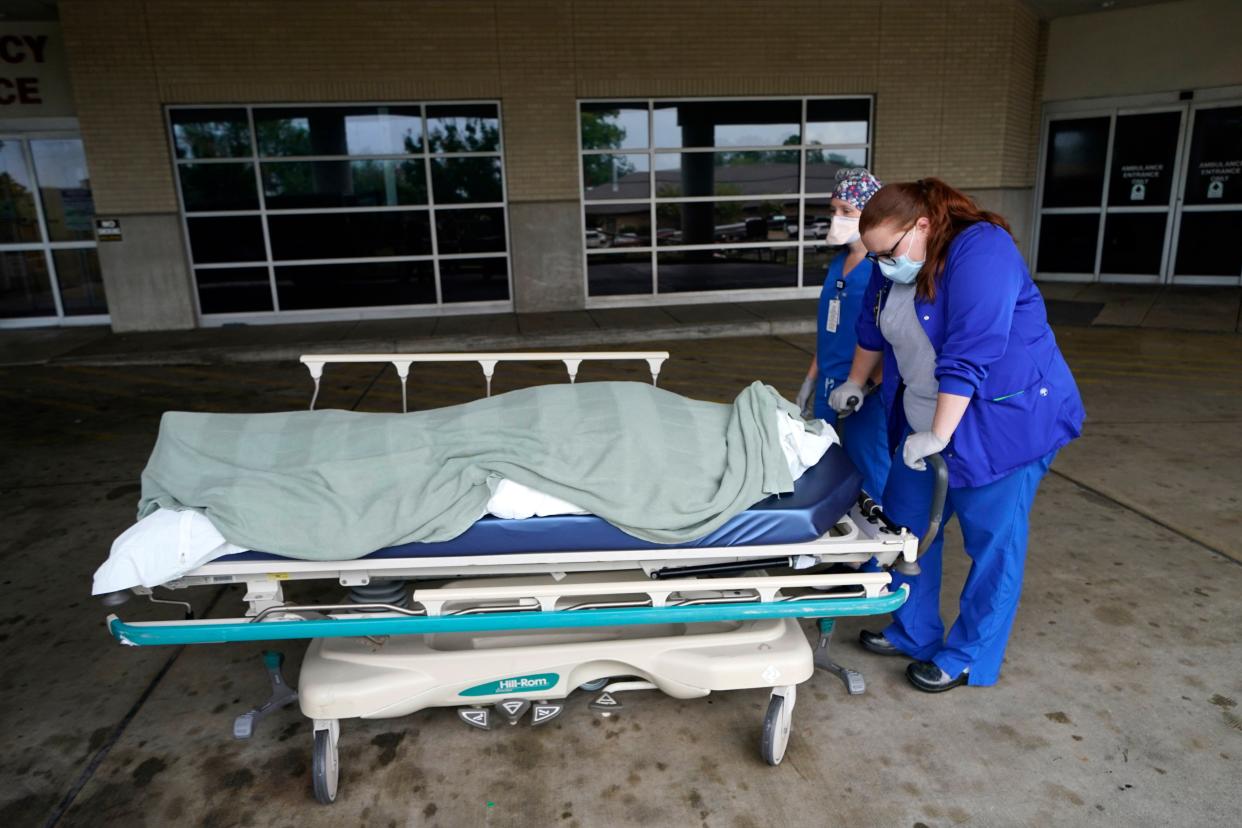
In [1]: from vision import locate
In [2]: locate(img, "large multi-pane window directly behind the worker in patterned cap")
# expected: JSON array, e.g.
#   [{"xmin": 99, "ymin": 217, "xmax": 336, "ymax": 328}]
[{"xmin": 579, "ymin": 98, "xmax": 872, "ymax": 302}]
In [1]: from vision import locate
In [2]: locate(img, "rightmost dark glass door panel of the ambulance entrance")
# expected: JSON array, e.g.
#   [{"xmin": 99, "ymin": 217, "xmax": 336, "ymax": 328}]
[{"xmin": 1172, "ymin": 102, "xmax": 1242, "ymax": 286}]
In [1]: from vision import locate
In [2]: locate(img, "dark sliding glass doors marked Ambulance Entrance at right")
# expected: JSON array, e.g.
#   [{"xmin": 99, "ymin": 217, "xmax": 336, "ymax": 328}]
[{"xmin": 1033, "ymin": 94, "xmax": 1242, "ymax": 284}]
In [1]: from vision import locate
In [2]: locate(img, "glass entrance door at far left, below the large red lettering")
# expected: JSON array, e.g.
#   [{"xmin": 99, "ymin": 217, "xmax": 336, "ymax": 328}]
[{"xmin": 0, "ymin": 134, "xmax": 108, "ymax": 328}]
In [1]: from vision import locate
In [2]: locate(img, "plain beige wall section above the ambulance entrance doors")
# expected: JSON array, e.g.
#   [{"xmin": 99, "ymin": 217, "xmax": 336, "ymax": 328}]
[{"xmin": 1043, "ymin": 0, "xmax": 1242, "ymax": 101}]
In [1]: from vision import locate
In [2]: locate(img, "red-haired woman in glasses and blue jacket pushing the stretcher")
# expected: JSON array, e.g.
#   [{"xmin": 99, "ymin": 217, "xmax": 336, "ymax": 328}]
[{"xmin": 828, "ymin": 179, "xmax": 1084, "ymax": 693}]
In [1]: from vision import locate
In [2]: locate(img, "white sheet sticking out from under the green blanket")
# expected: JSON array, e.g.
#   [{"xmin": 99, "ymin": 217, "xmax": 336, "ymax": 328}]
[{"xmin": 91, "ymin": 411, "xmax": 840, "ymax": 595}]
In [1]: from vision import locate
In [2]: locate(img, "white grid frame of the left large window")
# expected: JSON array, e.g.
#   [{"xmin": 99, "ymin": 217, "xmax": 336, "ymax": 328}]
[{"xmin": 164, "ymin": 99, "xmax": 514, "ymax": 328}]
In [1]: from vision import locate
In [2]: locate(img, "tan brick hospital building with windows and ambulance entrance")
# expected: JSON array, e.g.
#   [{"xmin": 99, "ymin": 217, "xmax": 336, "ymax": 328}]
[{"xmin": 0, "ymin": 0, "xmax": 1242, "ymax": 331}]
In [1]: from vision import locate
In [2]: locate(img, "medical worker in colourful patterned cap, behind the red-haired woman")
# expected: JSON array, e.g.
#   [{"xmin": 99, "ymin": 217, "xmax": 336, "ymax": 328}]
[{"xmin": 797, "ymin": 168, "xmax": 893, "ymax": 502}]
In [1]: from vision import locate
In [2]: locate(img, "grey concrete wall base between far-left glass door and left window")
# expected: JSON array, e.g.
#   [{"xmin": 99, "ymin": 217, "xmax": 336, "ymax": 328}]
[{"xmin": 99, "ymin": 214, "xmax": 197, "ymax": 333}]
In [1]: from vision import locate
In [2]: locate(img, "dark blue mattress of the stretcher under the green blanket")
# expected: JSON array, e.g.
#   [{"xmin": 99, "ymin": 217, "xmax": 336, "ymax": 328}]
[{"xmin": 214, "ymin": 446, "xmax": 862, "ymax": 564}]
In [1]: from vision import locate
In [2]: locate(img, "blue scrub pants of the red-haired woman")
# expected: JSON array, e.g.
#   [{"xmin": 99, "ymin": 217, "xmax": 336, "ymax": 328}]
[{"xmin": 884, "ymin": 441, "xmax": 1056, "ymax": 686}]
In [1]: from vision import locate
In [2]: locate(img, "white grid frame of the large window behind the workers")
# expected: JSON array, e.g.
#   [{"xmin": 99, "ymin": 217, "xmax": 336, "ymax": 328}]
[{"xmin": 574, "ymin": 93, "xmax": 876, "ymax": 309}]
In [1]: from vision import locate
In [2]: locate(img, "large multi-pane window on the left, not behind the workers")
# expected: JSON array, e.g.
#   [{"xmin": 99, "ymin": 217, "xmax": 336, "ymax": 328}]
[{"xmin": 169, "ymin": 103, "xmax": 510, "ymax": 317}]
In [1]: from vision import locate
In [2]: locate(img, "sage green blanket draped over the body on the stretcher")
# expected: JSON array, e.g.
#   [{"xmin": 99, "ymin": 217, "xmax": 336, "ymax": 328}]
[{"xmin": 139, "ymin": 382, "xmax": 796, "ymax": 560}]
